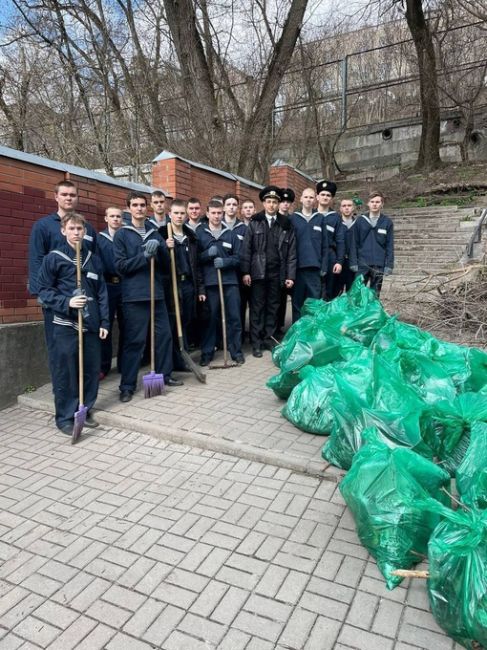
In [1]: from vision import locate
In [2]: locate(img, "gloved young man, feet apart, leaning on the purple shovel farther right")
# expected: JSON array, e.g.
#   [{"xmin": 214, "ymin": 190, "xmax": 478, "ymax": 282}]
[{"xmin": 113, "ymin": 192, "xmax": 183, "ymax": 402}]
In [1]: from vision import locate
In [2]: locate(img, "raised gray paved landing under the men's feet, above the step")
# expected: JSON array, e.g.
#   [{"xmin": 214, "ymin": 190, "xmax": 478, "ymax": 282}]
[{"xmin": 19, "ymin": 352, "xmax": 341, "ymax": 480}]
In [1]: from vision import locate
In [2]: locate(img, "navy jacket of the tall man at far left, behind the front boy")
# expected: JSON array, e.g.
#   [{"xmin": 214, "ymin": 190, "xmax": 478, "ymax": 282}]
[{"xmin": 28, "ymin": 212, "xmax": 96, "ymax": 296}]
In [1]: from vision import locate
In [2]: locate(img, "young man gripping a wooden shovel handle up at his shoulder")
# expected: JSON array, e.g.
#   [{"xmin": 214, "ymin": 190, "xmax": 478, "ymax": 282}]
[{"xmin": 160, "ymin": 199, "xmax": 205, "ymax": 370}]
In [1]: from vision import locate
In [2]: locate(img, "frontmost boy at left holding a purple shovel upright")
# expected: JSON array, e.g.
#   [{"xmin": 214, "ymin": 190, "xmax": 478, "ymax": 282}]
[{"xmin": 36, "ymin": 212, "xmax": 108, "ymax": 435}]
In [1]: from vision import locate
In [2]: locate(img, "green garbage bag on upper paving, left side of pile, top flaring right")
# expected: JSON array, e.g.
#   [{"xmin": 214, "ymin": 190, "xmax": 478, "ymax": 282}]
[{"xmin": 282, "ymin": 348, "xmax": 372, "ymax": 435}]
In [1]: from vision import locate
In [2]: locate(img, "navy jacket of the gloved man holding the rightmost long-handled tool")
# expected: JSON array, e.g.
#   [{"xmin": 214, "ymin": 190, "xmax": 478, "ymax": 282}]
[{"xmin": 196, "ymin": 222, "xmax": 240, "ymax": 287}]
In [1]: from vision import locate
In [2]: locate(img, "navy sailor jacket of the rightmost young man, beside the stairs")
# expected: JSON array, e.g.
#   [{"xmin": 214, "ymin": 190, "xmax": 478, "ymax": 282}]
[{"xmin": 349, "ymin": 213, "xmax": 394, "ymax": 273}]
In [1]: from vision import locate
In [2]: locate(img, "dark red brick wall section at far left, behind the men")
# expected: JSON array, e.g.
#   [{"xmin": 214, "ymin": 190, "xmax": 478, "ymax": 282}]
[{"xmin": 0, "ymin": 156, "xmax": 152, "ymax": 323}]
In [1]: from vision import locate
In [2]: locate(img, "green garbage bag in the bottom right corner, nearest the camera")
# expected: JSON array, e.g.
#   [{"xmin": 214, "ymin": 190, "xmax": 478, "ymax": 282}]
[{"xmin": 427, "ymin": 499, "xmax": 487, "ymax": 648}]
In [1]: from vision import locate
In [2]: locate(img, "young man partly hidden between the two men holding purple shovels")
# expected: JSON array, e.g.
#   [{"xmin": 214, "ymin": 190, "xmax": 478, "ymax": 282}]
[{"xmin": 97, "ymin": 206, "xmax": 123, "ymax": 379}]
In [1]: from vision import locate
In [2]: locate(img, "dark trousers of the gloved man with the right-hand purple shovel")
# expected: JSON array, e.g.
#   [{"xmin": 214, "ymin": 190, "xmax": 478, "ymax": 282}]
[{"xmin": 120, "ymin": 300, "xmax": 173, "ymax": 392}]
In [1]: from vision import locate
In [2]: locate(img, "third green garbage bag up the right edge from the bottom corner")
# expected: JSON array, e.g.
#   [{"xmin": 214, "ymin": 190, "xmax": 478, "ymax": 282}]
[{"xmin": 428, "ymin": 393, "xmax": 487, "ymax": 475}]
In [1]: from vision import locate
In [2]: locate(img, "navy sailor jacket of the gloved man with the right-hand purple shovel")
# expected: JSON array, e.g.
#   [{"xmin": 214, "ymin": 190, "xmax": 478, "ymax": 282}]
[{"xmin": 113, "ymin": 220, "xmax": 169, "ymax": 302}]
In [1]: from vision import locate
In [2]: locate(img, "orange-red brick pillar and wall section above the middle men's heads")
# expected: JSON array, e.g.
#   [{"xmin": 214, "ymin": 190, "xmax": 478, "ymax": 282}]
[{"xmin": 152, "ymin": 156, "xmax": 260, "ymax": 210}]
